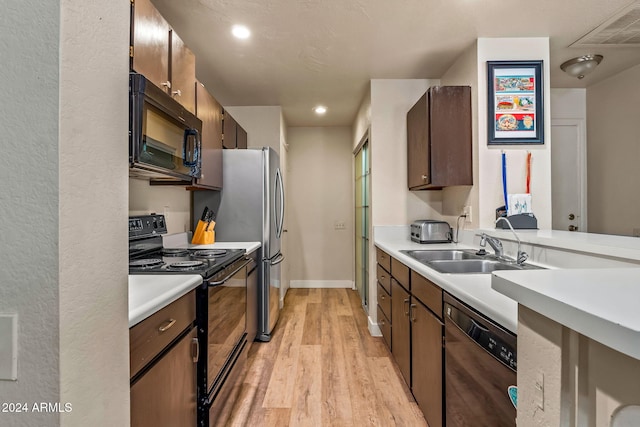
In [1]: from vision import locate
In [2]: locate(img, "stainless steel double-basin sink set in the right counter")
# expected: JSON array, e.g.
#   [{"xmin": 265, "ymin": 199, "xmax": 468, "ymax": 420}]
[{"xmin": 400, "ymin": 249, "xmax": 542, "ymax": 274}]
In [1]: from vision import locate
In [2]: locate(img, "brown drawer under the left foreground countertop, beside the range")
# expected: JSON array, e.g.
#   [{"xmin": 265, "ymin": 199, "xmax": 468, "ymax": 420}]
[{"xmin": 129, "ymin": 291, "xmax": 196, "ymax": 377}]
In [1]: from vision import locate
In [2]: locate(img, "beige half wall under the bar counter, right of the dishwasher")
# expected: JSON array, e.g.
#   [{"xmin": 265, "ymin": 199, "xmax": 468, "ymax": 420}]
[{"xmin": 518, "ymin": 306, "xmax": 640, "ymax": 427}]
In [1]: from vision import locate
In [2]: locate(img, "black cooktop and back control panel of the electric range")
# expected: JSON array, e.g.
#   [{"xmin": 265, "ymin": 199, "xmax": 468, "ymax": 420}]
[{"xmin": 129, "ymin": 215, "xmax": 245, "ymax": 280}]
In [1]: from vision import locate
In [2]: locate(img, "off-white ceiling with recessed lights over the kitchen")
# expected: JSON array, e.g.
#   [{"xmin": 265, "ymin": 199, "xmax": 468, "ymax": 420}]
[{"xmin": 153, "ymin": 0, "xmax": 640, "ymax": 126}]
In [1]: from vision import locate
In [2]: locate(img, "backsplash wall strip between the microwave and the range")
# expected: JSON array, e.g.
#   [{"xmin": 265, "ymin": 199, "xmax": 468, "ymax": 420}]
[{"xmin": 129, "ymin": 178, "xmax": 193, "ymax": 234}]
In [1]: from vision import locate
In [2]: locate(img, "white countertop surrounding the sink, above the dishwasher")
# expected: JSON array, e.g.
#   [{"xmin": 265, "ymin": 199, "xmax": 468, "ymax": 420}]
[{"xmin": 374, "ymin": 227, "xmax": 518, "ymax": 334}]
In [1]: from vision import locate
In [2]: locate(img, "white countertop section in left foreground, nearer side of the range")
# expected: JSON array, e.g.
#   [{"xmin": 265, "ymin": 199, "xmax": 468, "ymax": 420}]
[{"xmin": 129, "ymin": 274, "xmax": 202, "ymax": 327}]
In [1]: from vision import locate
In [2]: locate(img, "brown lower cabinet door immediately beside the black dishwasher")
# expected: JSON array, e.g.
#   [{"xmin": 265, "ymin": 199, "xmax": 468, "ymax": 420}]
[{"xmin": 411, "ymin": 298, "xmax": 444, "ymax": 427}]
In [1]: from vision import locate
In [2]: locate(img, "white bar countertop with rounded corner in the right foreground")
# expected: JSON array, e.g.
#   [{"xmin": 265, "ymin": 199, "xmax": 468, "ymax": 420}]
[{"xmin": 491, "ymin": 268, "xmax": 640, "ymax": 359}]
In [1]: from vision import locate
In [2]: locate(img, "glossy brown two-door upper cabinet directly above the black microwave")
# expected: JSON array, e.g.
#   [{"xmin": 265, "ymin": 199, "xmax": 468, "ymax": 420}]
[{"xmin": 129, "ymin": 0, "xmax": 196, "ymax": 113}]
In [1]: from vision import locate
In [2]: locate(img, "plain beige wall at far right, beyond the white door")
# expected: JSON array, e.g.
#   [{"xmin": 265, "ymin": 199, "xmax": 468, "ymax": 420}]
[{"xmin": 587, "ymin": 66, "xmax": 640, "ymax": 235}]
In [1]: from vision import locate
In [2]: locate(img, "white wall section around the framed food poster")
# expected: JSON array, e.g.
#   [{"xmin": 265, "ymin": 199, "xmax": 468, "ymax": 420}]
[{"xmin": 477, "ymin": 37, "xmax": 553, "ymax": 229}]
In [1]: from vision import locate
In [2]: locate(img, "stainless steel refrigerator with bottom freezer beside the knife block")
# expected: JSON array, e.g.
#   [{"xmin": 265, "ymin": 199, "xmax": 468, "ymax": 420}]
[{"xmin": 215, "ymin": 147, "xmax": 284, "ymax": 341}]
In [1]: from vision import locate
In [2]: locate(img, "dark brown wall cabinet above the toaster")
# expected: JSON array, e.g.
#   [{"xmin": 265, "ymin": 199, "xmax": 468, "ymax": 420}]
[{"xmin": 407, "ymin": 86, "xmax": 473, "ymax": 190}]
